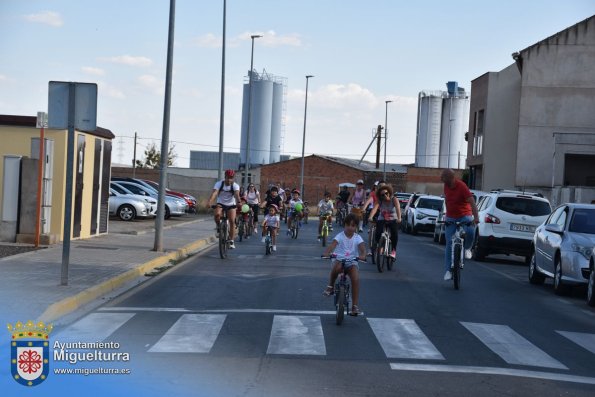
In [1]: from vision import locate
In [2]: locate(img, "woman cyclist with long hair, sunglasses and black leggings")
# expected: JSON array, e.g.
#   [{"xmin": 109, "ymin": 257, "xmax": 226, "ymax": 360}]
[{"xmin": 368, "ymin": 185, "xmax": 401, "ymax": 259}]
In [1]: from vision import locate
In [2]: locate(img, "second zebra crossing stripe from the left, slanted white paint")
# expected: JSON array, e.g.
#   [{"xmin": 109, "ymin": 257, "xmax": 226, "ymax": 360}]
[{"xmin": 149, "ymin": 314, "xmax": 227, "ymax": 353}]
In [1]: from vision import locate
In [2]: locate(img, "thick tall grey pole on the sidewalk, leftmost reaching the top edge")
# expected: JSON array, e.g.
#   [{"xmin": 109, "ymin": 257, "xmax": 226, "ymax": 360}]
[{"xmin": 153, "ymin": 0, "xmax": 176, "ymax": 252}]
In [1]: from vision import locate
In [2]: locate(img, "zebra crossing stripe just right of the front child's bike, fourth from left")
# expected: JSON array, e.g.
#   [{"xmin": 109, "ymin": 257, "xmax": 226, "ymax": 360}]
[{"xmin": 368, "ymin": 318, "xmax": 444, "ymax": 360}]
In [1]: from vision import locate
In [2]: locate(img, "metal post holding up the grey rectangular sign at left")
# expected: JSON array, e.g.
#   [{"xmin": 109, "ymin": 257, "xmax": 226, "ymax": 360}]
[{"xmin": 60, "ymin": 83, "xmax": 76, "ymax": 285}]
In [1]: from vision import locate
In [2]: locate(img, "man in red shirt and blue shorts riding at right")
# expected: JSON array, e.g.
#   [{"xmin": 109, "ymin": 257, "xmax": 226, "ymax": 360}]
[{"xmin": 440, "ymin": 169, "xmax": 479, "ymax": 280}]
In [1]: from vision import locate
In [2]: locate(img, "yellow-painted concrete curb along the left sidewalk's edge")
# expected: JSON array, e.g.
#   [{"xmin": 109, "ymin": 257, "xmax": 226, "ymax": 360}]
[{"xmin": 39, "ymin": 236, "xmax": 216, "ymax": 323}]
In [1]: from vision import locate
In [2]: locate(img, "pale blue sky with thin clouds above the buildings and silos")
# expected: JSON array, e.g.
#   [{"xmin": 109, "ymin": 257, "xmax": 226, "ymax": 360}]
[{"xmin": 0, "ymin": 0, "xmax": 595, "ymax": 167}]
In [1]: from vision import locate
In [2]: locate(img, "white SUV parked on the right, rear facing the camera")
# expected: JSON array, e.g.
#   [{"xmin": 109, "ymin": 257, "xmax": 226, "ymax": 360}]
[{"xmin": 473, "ymin": 190, "xmax": 551, "ymax": 264}]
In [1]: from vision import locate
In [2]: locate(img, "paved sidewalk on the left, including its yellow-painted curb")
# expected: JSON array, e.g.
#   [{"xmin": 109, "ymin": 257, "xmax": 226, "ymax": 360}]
[{"xmin": 0, "ymin": 215, "xmax": 216, "ymax": 325}]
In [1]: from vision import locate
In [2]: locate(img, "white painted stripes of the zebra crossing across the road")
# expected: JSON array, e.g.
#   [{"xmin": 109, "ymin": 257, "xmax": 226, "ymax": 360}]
[{"xmin": 55, "ymin": 308, "xmax": 595, "ymax": 374}]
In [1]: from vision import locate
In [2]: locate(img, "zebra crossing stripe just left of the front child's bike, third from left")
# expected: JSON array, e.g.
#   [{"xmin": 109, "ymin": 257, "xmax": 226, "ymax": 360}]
[{"xmin": 267, "ymin": 316, "xmax": 326, "ymax": 356}]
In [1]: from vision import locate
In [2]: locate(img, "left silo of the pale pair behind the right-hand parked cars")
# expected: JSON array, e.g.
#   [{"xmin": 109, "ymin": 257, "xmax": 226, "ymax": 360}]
[{"xmin": 415, "ymin": 92, "xmax": 442, "ymax": 168}]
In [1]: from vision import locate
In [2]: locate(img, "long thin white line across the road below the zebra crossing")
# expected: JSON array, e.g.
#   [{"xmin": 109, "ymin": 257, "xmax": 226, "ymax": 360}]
[{"xmin": 390, "ymin": 363, "xmax": 595, "ymax": 385}]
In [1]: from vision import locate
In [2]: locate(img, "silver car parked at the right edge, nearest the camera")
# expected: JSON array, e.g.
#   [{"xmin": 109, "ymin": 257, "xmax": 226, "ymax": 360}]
[{"xmin": 529, "ymin": 203, "xmax": 595, "ymax": 305}]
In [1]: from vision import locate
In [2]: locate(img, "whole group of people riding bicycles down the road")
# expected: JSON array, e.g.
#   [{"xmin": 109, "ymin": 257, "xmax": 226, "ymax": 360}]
[{"xmin": 209, "ymin": 170, "xmax": 479, "ymax": 316}]
